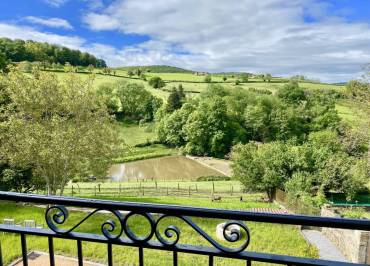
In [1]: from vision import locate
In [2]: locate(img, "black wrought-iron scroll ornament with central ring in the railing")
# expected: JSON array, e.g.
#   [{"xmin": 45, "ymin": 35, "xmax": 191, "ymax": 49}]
[{"xmin": 45, "ymin": 205, "xmax": 250, "ymax": 253}]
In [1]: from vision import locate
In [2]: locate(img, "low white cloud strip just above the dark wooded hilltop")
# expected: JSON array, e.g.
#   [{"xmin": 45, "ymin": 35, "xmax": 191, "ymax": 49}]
[{"xmin": 0, "ymin": 23, "xmax": 86, "ymax": 49}]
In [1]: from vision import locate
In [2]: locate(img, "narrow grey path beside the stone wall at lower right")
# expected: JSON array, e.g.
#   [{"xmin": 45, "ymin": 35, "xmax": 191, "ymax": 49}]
[{"xmin": 302, "ymin": 230, "xmax": 348, "ymax": 262}]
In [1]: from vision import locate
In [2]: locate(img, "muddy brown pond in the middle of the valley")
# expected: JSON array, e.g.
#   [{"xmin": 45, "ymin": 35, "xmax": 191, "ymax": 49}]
[{"xmin": 108, "ymin": 156, "xmax": 223, "ymax": 181}]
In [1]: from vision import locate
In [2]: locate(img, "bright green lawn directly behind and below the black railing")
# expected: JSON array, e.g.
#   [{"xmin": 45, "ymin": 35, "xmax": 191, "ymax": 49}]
[{"xmin": 0, "ymin": 197, "xmax": 318, "ymax": 265}]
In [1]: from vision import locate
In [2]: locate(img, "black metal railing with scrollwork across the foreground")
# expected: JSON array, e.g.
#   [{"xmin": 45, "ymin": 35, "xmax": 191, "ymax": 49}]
[{"xmin": 0, "ymin": 192, "xmax": 370, "ymax": 266}]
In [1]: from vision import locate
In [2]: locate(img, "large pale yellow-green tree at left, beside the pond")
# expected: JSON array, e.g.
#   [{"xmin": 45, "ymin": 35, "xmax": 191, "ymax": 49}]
[{"xmin": 1, "ymin": 71, "xmax": 120, "ymax": 195}]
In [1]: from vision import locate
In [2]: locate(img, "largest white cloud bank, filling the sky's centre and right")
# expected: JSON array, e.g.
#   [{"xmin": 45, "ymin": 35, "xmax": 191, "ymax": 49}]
[{"xmin": 84, "ymin": 0, "xmax": 370, "ymax": 81}]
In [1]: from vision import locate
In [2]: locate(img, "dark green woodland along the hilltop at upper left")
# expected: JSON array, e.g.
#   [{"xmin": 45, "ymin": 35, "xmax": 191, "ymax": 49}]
[{"xmin": 0, "ymin": 38, "xmax": 107, "ymax": 67}]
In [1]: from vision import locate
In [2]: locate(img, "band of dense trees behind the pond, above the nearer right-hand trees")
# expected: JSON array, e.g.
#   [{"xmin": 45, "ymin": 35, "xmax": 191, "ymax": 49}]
[{"xmin": 156, "ymin": 82, "xmax": 340, "ymax": 157}]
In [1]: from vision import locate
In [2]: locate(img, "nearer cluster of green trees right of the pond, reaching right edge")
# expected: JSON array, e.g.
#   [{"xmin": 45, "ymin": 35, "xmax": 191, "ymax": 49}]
[{"xmin": 231, "ymin": 130, "xmax": 370, "ymax": 205}]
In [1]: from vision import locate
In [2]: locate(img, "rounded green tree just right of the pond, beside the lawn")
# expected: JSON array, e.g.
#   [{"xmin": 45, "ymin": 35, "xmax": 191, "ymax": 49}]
[{"xmin": 231, "ymin": 142, "xmax": 288, "ymax": 202}]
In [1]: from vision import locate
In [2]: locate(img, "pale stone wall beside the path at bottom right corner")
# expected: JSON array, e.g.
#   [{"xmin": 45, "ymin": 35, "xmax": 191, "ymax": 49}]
[{"xmin": 321, "ymin": 207, "xmax": 370, "ymax": 264}]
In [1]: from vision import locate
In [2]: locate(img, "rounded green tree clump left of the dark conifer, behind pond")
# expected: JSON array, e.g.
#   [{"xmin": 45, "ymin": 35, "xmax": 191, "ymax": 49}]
[{"xmin": 113, "ymin": 82, "xmax": 162, "ymax": 121}]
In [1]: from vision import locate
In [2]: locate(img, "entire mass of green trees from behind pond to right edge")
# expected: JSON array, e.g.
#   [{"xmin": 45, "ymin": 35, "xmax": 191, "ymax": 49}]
[{"xmin": 156, "ymin": 81, "xmax": 370, "ymax": 202}]
